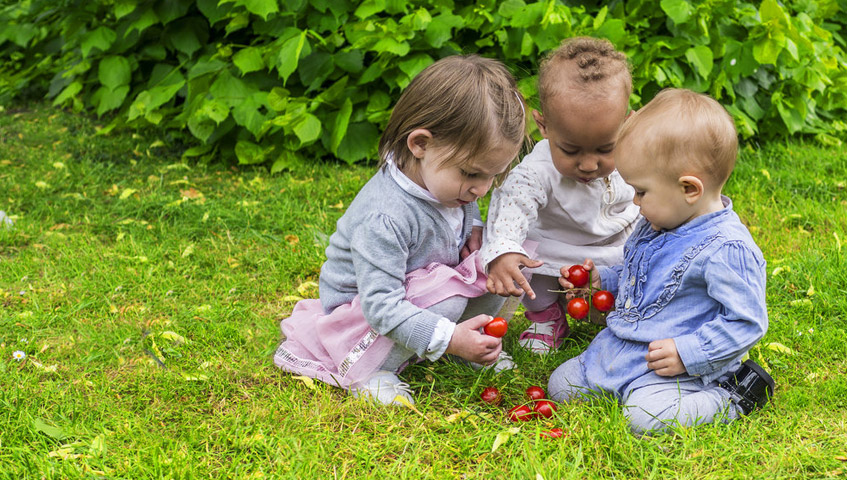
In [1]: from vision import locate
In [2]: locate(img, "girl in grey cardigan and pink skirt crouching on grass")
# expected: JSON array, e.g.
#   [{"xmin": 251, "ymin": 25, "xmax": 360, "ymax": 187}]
[{"xmin": 274, "ymin": 55, "xmax": 527, "ymax": 404}]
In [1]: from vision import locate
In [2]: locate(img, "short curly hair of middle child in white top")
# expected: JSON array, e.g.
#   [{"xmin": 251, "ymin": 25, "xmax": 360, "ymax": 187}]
[{"xmin": 538, "ymin": 37, "xmax": 632, "ymax": 112}]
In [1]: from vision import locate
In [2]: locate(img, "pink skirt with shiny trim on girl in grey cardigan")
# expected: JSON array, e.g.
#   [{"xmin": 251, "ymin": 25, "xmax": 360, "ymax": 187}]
[{"xmin": 274, "ymin": 251, "xmax": 487, "ymax": 388}]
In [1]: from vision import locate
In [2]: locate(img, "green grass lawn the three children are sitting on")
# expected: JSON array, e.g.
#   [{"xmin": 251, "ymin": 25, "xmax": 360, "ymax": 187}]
[{"xmin": 0, "ymin": 107, "xmax": 847, "ymax": 480}]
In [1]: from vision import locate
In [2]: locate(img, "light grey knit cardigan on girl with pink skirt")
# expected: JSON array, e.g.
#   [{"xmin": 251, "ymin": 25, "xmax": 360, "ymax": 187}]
[{"xmin": 320, "ymin": 168, "xmax": 480, "ymax": 357}]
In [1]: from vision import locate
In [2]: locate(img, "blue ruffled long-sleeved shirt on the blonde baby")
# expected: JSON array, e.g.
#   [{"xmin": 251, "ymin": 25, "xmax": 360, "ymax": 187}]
[{"xmin": 582, "ymin": 197, "xmax": 768, "ymax": 395}]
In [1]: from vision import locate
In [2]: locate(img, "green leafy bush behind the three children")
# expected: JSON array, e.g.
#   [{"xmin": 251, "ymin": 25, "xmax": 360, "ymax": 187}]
[{"xmin": 0, "ymin": 0, "xmax": 847, "ymax": 170}]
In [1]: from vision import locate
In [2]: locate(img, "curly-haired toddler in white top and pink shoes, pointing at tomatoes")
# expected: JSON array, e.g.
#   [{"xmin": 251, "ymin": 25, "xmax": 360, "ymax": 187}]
[{"xmin": 482, "ymin": 37, "xmax": 639, "ymax": 353}]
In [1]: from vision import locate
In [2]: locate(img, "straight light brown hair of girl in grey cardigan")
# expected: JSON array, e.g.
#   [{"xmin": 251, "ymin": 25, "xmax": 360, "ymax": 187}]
[{"xmin": 379, "ymin": 55, "xmax": 528, "ymax": 174}]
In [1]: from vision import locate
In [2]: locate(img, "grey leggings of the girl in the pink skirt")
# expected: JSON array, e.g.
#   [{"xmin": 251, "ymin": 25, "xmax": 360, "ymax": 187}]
[{"xmin": 381, "ymin": 293, "xmax": 506, "ymax": 372}]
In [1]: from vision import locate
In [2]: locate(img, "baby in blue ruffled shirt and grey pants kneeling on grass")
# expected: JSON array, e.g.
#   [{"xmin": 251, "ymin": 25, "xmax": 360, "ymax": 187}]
[{"xmin": 548, "ymin": 89, "xmax": 773, "ymax": 434}]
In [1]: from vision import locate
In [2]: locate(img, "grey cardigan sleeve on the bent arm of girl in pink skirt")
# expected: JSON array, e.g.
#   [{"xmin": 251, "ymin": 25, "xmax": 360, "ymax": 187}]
[{"xmin": 350, "ymin": 214, "xmax": 441, "ymax": 357}]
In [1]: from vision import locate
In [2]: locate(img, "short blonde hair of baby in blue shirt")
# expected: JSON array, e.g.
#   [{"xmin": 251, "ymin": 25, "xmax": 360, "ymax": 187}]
[{"xmin": 618, "ymin": 88, "xmax": 738, "ymax": 188}]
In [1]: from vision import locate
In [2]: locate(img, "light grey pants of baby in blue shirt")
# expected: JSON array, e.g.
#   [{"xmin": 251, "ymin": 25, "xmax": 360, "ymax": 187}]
[{"xmin": 547, "ymin": 357, "xmax": 739, "ymax": 435}]
